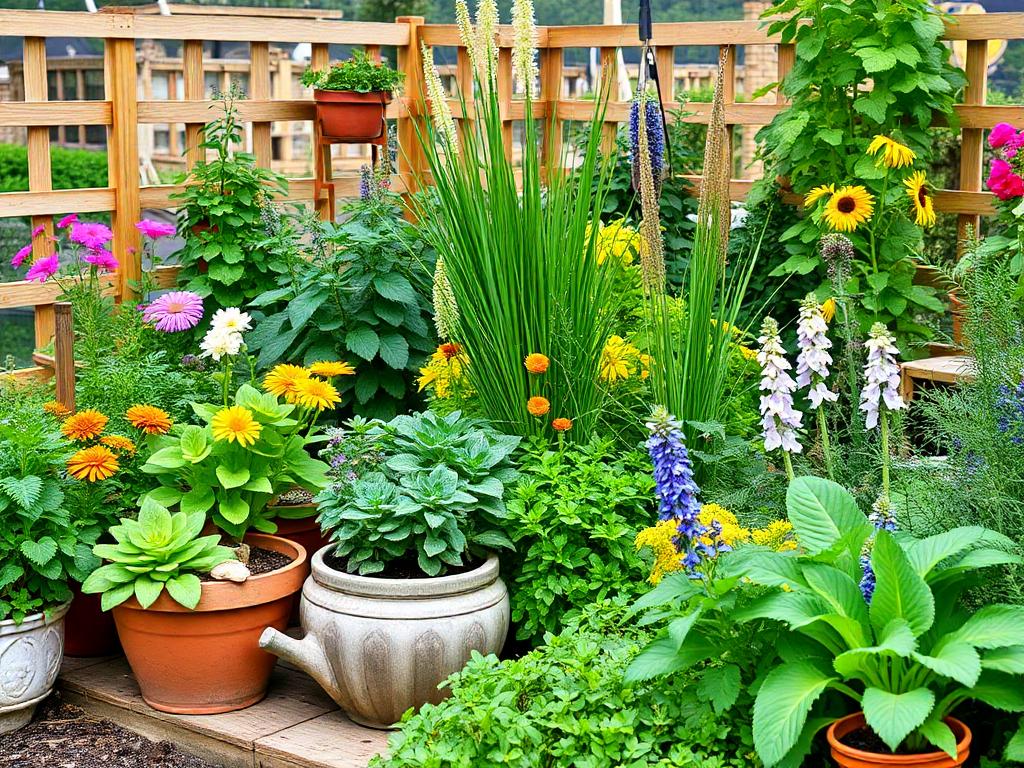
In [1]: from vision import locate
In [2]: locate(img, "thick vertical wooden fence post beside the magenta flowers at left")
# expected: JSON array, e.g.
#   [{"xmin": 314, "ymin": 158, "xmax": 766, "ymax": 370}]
[{"xmin": 105, "ymin": 39, "xmax": 142, "ymax": 299}]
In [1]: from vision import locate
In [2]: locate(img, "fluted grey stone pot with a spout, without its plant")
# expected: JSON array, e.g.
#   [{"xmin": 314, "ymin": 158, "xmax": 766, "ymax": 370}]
[{"xmin": 260, "ymin": 546, "xmax": 509, "ymax": 728}]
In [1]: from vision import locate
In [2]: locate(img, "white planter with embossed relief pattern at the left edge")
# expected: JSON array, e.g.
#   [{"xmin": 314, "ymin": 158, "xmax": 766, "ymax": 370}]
[{"xmin": 0, "ymin": 603, "xmax": 71, "ymax": 733}]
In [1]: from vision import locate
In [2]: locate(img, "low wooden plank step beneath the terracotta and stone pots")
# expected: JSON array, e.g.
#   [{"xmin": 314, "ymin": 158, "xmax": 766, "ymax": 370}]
[{"xmin": 57, "ymin": 657, "xmax": 387, "ymax": 768}]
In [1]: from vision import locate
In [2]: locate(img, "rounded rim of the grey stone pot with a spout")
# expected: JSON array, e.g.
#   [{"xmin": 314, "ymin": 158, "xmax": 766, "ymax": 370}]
[{"xmin": 312, "ymin": 544, "xmax": 499, "ymax": 600}]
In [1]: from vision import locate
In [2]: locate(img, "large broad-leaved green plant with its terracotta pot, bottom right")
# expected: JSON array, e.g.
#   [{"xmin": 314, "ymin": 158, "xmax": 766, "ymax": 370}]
[{"xmin": 732, "ymin": 477, "xmax": 1024, "ymax": 768}]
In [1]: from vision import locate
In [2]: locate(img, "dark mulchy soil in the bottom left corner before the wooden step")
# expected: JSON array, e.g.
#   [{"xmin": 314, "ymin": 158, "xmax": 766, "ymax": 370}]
[{"xmin": 0, "ymin": 694, "xmax": 217, "ymax": 768}]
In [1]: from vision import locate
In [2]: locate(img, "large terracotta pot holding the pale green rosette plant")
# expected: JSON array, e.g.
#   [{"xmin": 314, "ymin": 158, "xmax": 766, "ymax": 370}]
[{"xmin": 114, "ymin": 534, "xmax": 306, "ymax": 715}]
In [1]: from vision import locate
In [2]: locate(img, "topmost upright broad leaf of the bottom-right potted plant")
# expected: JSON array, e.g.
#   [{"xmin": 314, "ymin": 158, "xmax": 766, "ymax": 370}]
[{"xmin": 785, "ymin": 477, "xmax": 871, "ymax": 555}]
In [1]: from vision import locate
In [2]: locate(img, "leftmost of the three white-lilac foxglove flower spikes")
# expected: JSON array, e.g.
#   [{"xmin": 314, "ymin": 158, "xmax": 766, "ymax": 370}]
[{"xmin": 758, "ymin": 317, "xmax": 804, "ymax": 454}]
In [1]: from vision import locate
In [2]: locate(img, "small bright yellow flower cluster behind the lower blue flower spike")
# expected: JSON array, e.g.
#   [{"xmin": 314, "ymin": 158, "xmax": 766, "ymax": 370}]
[{"xmin": 634, "ymin": 504, "xmax": 797, "ymax": 584}]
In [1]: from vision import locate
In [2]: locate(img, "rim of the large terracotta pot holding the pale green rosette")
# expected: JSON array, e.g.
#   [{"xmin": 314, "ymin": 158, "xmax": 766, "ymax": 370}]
[{"xmin": 115, "ymin": 534, "xmax": 306, "ymax": 613}]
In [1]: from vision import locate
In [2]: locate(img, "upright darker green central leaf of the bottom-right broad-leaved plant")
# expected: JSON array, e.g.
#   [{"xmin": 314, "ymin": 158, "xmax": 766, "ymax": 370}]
[{"xmin": 868, "ymin": 530, "xmax": 935, "ymax": 637}]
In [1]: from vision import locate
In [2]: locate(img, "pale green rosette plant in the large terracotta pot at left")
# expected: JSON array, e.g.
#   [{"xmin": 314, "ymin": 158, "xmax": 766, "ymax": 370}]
[{"xmin": 82, "ymin": 499, "xmax": 236, "ymax": 610}]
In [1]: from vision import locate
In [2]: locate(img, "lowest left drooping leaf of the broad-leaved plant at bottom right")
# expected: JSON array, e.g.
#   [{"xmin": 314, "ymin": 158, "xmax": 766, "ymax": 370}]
[{"xmin": 754, "ymin": 662, "xmax": 837, "ymax": 767}]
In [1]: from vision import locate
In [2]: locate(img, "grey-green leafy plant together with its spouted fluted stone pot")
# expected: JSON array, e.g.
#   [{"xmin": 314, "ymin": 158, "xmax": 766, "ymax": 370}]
[{"xmin": 260, "ymin": 412, "xmax": 519, "ymax": 728}]
